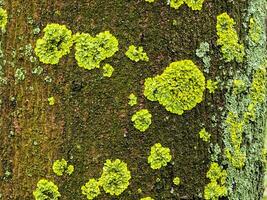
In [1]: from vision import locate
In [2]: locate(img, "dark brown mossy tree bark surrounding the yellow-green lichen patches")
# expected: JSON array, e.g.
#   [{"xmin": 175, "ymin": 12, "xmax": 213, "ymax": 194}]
[{"xmin": 0, "ymin": 0, "xmax": 265, "ymax": 200}]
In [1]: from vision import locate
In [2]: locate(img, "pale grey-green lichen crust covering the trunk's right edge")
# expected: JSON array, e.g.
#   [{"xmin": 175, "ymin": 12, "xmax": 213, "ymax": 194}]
[{"xmin": 223, "ymin": 0, "xmax": 267, "ymax": 200}]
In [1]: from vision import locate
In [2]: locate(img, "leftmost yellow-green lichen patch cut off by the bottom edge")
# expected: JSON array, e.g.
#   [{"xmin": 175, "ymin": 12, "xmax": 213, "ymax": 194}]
[{"xmin": 33, "ymin": 179, "xmax": 61, "ymax": 200}]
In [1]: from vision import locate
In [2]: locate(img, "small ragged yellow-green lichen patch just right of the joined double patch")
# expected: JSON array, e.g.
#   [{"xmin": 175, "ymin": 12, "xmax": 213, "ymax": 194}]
[{"xmin": 125, "ymin": 45, "xmax": 149, "ymax": 62}]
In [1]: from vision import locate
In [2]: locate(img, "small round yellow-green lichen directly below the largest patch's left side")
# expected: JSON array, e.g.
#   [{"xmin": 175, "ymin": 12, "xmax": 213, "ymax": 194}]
[{"xmin": 131, "ymin": 109, "xmax": 152, "ymax": 132}]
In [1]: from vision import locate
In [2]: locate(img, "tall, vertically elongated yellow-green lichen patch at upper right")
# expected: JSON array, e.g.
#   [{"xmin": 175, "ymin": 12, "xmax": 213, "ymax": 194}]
[{"xmin": 216, "ymin": 13, "xmax": 245, "ymax": 63}]
